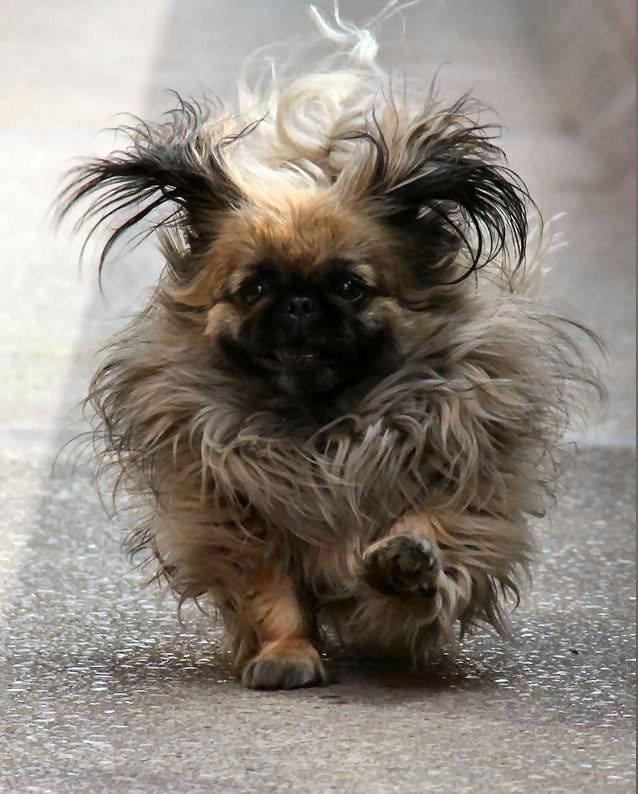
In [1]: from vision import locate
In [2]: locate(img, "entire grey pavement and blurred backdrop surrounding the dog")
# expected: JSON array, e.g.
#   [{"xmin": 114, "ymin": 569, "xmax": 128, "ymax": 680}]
[{"xmin": 0, "ymin": 0, "xmax": 635, "ymax": 792}]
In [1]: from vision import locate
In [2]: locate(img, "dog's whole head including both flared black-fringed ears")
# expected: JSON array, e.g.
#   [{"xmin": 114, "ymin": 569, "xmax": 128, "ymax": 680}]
[{"xmin": 61, "ymin": 96, "xmax": 527, "ymax": 400}]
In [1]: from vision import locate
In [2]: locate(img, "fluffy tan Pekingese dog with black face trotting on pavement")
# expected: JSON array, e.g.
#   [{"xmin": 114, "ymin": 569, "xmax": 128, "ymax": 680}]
[{"xmin": 60, "ymin": 11, "xmax": 597, "ymax": 689}]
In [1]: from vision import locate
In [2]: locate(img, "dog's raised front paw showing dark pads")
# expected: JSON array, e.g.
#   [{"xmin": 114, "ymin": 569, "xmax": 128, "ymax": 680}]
[{"xmin": 363, "ymin": 534, "xmax": 441, "ymax": 598}]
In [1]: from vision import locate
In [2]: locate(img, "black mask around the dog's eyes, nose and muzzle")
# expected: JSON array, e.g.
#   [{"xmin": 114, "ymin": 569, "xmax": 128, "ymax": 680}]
[{"xmin": 218, "ymin": 258, "xmax": 393, "ymax": 395}]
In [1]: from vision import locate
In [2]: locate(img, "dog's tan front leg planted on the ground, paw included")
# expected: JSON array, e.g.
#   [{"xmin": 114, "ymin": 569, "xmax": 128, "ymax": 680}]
[{"xmin": 241, "ymin": 564, "xmax": 327, "ymax": 689}]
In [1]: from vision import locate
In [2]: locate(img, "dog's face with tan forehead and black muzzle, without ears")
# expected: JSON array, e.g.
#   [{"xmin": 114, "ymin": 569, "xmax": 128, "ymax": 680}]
[{"xmin": 197, "ymin": 193, "xmax": 400, "ymax": 399}]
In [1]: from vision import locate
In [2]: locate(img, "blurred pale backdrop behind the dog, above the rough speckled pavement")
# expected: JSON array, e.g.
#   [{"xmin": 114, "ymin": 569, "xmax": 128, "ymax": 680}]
[{"xmin": 0, "ymin": 0, "xmax": 635, "ymax": 444}]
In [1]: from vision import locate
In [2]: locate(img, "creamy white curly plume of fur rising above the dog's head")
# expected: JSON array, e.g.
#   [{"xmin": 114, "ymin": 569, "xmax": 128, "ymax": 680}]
[{"xmin": 235, "ymin": 0, "xmax": 415, "ymax": 188}]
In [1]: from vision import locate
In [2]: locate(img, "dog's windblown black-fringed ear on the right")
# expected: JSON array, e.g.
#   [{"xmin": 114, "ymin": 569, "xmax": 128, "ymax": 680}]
[{"xmin": 352, "ymin": 98, "xmax": 533, "ymax": 286}]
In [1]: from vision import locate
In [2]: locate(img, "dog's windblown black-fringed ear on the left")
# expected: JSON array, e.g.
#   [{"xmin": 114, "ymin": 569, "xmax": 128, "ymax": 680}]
[{"xmin": 57, "ymin": 99, "xmax": 245, "ymax": 276}]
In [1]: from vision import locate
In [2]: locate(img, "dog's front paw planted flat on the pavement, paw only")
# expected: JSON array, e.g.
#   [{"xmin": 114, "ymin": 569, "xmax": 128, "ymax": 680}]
[{"xmin": 241, "ymin": 642, "xmax": 328, "ymax": 689}]
